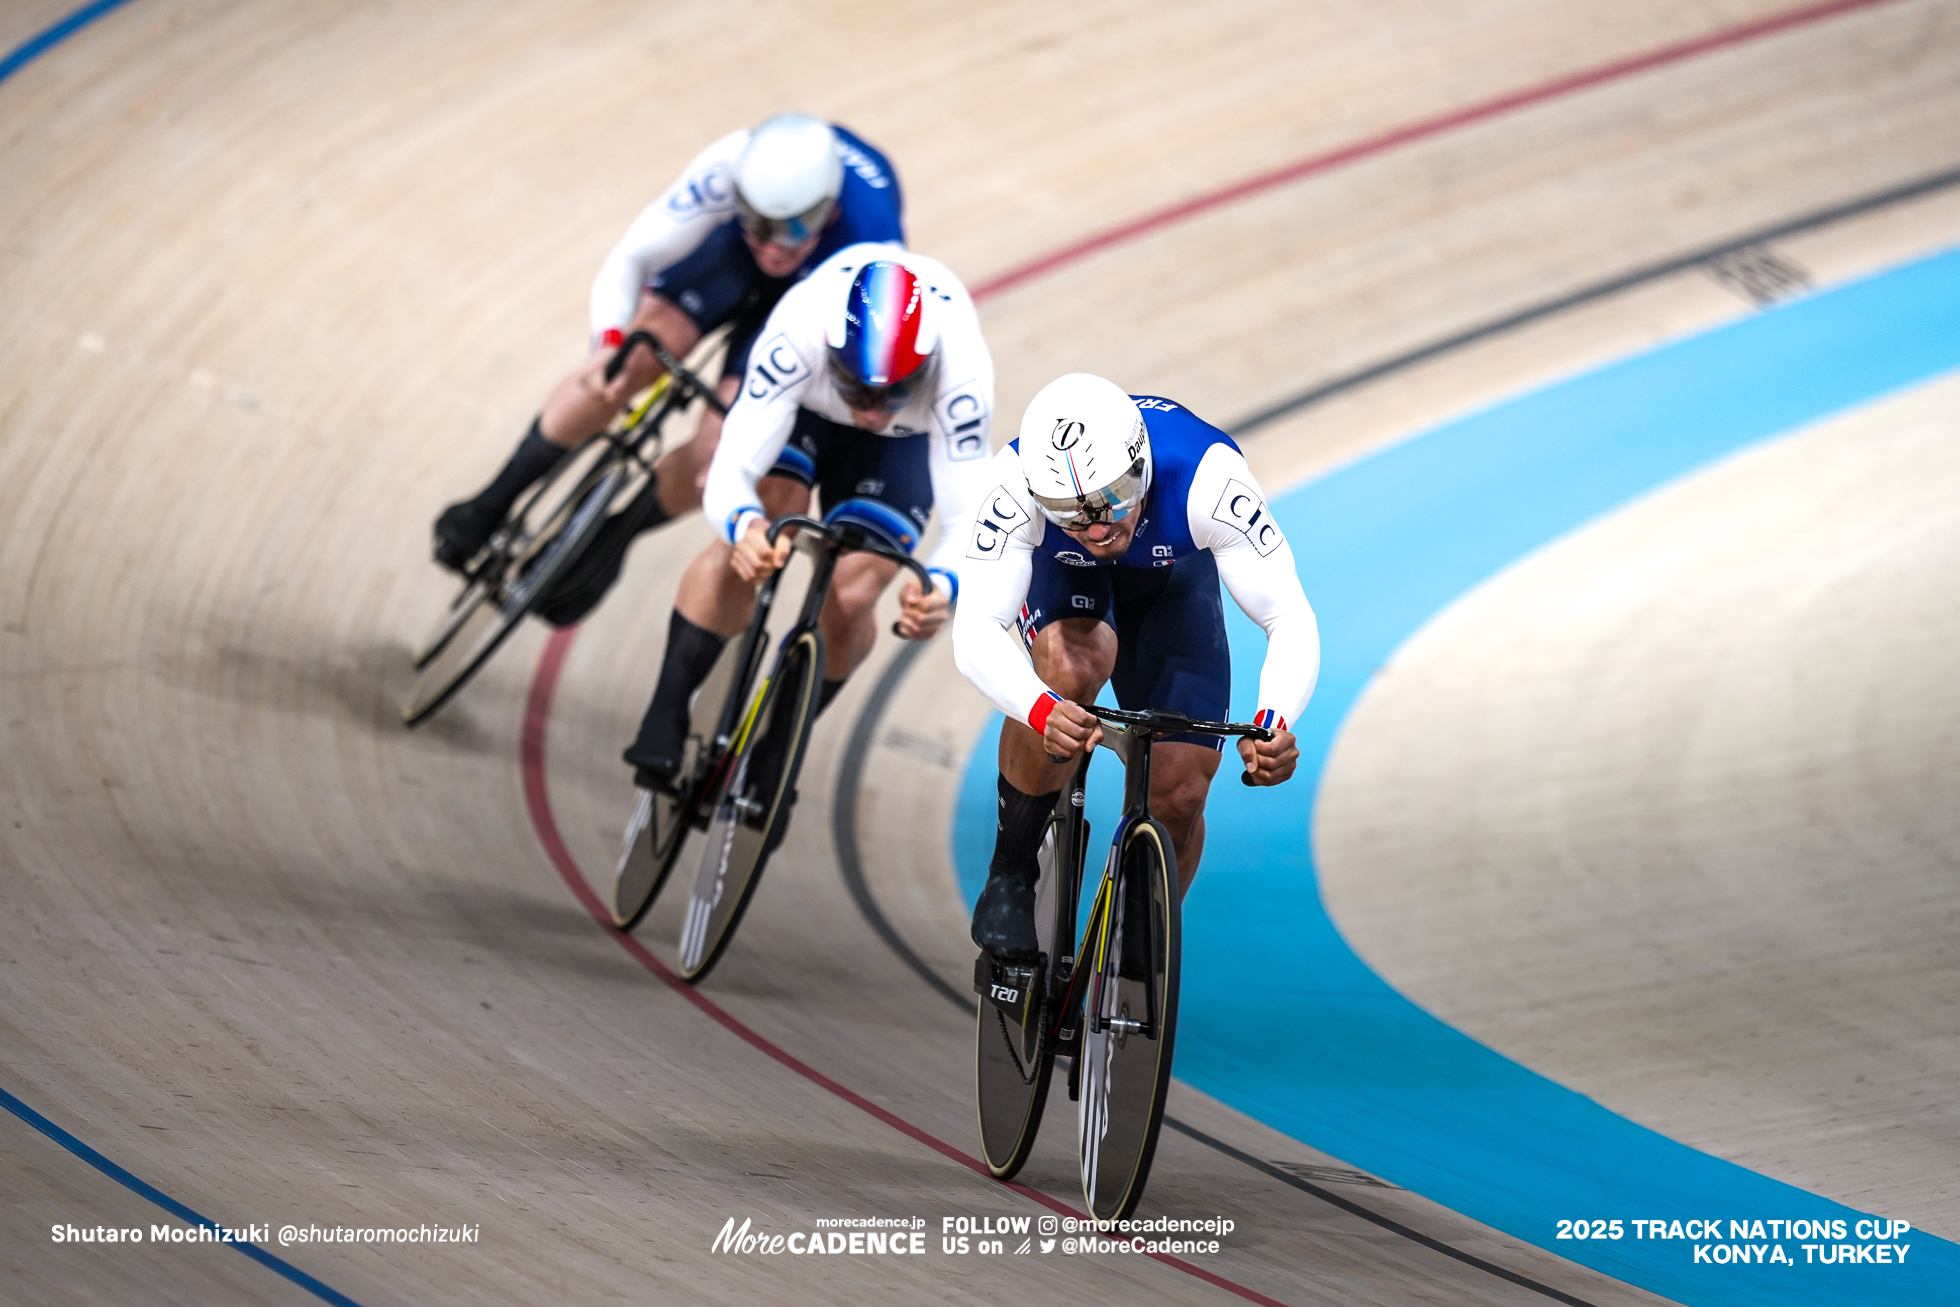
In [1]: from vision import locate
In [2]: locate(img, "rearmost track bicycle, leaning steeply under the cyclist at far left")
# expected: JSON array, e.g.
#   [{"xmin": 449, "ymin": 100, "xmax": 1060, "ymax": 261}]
[{"xmin": 402, "ymin": 331, "xmax": 727, "ymax": 727}]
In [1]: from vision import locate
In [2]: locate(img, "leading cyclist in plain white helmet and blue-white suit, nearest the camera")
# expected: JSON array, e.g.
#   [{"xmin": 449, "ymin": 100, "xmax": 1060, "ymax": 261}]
[{"xmin": 953, "ymin": 372, "xmax": 1321, "ymax": 962}]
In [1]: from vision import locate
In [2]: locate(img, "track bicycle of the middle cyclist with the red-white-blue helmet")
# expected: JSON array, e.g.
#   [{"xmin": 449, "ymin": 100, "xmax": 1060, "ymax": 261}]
[{"xmin": 612, "ymin": 500, "xmax": 933, "ymax": 984}]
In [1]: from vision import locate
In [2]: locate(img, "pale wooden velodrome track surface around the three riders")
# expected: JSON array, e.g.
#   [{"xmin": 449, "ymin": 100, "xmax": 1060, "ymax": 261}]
[{"xmin": 0, "ymin": 0, "xmax": 1960, "ymax": 1303}]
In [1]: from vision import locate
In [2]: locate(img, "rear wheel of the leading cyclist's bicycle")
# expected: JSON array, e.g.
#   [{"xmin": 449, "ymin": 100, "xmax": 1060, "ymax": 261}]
[{"xmin": 974, "ymin": 803, "xmax": 1088, "ymax": 1180}]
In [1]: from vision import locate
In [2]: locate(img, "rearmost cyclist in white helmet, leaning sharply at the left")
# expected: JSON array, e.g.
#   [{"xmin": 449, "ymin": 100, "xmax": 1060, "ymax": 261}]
[{"xmin": 435, "ymin": 114, "xmax": 906, "ymax": 625}]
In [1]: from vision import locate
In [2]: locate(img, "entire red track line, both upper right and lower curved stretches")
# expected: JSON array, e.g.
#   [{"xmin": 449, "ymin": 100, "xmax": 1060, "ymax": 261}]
[{"xmin": 521, "ymin": 0, "xmax": 1893, "ymax": 1307}]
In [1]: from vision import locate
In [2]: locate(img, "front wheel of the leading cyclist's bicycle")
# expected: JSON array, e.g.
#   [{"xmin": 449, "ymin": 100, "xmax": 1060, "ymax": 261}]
[{"xmin": 1080, "ymin": 821, "xmax": 1180, "ymax": 1221}]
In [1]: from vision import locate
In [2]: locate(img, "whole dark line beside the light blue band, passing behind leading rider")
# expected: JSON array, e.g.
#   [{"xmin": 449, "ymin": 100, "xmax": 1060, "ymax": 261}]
[{"xmin": 831, "ymin": 169, "xmax": 1960, "ymax": 1307}]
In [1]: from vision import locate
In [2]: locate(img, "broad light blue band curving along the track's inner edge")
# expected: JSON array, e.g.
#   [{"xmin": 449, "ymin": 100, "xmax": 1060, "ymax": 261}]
[{"xmin": 955, "ymin": 242, "xmax": 1960, "ymax": 1307}]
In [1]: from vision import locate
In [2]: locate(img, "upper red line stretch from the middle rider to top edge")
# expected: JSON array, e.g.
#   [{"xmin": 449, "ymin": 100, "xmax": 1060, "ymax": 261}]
[{"xmin": 972, "ymin": 0, "xmax": 1893, "ymax": 302}]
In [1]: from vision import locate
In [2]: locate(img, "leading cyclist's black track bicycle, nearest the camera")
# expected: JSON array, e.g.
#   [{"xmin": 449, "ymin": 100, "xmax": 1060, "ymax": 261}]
[{"xmin": 974, "ymin": 705, "xmax": 1272, "ymax": 1221}]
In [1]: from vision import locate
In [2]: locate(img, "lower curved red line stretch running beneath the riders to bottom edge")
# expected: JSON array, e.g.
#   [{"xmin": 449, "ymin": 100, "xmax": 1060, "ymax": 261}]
[{"xmin": 523, "ymin": 627, "xmax": 1286, "ymax": 1307}]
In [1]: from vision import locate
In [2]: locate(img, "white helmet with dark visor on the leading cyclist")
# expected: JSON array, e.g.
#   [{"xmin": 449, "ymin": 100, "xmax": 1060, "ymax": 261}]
[{"xmin": 1021, "ymin": 372, "xmax": 1151, "ymax": 531}]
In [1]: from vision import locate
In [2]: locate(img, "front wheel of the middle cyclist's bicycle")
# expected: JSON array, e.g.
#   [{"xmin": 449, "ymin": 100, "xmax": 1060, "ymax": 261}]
[{"xmin": 680, "ymin": 631, "xmax": 823, "ymax": 984}]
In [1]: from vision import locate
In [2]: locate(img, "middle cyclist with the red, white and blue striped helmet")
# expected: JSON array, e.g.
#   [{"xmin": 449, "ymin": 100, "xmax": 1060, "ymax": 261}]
[{"xmin": 623, "ymin": 245, "xmax": 994, "ymax": 834}]
